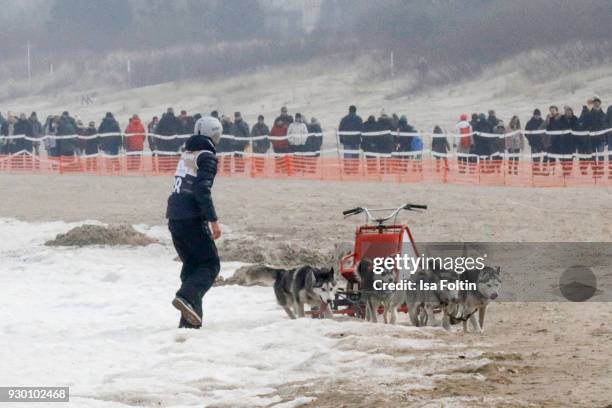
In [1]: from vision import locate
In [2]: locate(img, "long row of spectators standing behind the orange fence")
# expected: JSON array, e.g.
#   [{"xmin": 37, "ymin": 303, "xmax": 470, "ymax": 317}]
[{"xmin": 0, "ymin": 97, "xmax": 612, "ymax": 173}]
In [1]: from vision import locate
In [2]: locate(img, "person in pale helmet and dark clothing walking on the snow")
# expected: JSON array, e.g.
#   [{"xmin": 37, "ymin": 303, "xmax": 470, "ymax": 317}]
[{"xmin": 166, "ymin": 116, "xmax": 222, "ymax": 329}]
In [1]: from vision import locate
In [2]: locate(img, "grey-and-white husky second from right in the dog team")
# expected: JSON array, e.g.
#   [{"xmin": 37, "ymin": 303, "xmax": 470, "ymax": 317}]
[{"xmin": 391, "ymin": 269, "xmax": 459, "ymax": 330}]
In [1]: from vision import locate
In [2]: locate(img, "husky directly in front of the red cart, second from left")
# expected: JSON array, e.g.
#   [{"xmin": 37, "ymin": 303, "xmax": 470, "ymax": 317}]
[{"xmin": 357, "ymin": 259, "xmax": 395, "ymax": 324}]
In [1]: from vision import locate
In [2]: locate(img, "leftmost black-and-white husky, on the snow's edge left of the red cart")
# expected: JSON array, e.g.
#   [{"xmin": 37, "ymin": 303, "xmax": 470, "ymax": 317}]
[{"xmin": 274, "ymin": 265, "xmax": 336, "ymax": 319}]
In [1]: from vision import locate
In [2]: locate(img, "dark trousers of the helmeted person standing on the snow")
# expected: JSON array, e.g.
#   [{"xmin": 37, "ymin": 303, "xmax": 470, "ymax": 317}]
[{"xmin": 168, "ymin": 218, "xmax": 221, "ymax": 327}]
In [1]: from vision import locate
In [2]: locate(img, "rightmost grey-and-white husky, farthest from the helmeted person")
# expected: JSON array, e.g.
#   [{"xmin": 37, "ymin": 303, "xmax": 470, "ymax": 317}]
[{"xmin": 446, "ymin": 266, "xmax": 502, "ymax": 333}]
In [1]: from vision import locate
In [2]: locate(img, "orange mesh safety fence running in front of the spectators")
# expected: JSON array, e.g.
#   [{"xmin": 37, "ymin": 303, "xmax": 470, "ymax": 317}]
[{"xmin": 0, "ymin": 153, "xmax": 612, "ymax": 187}]
